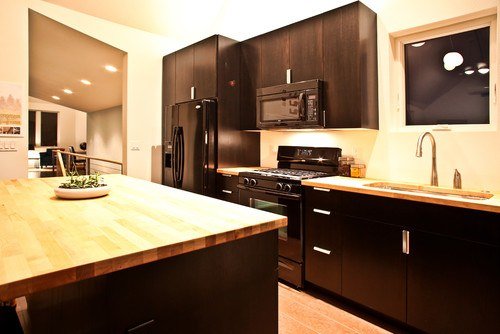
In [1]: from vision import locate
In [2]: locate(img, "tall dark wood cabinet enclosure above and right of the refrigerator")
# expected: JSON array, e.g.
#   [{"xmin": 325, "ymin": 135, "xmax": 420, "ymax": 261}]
[{"xmin": 162, "ymin": 35, "xmax": 260, "ymax": 168}]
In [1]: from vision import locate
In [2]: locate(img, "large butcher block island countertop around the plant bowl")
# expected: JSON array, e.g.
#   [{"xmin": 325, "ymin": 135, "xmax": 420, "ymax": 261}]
[{"xmin": 0, "ymin": 175, "xmax": 287, "ymax": 300}]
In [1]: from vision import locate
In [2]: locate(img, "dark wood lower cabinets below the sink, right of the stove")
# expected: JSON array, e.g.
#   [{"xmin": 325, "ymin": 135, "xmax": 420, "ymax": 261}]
[{"xmin": 305, "ymin": 187, "xmax": 500, "ymax": 334}]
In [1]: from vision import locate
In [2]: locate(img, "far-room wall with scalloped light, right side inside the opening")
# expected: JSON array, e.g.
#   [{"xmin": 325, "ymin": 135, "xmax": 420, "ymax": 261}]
[{"xmin": 87, "ymin": 106, "xmax": 122, "ymax": 173}]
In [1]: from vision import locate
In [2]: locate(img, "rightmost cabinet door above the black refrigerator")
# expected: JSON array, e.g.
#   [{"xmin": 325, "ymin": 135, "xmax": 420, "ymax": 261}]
[{"xmin": 193, "ymin": 36, "xmax": 217, "ymax": 99}]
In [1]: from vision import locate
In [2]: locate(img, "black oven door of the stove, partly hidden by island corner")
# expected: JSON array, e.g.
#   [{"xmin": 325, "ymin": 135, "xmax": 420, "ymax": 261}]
[{"xmin": 238, "ymin": 185, "xmax": 303, "ymax": 263}]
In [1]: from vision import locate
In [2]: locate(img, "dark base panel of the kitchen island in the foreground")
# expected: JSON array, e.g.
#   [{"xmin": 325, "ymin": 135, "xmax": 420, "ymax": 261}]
[{"xmin": 27, "ymin": 231, "xmax": 278, "ymax": 334}]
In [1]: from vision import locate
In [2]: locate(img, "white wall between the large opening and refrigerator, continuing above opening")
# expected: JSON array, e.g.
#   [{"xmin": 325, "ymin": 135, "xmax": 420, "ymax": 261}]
[{"xmin": 28, "ymin": 0, "xmax": 178, "ymax": 180}]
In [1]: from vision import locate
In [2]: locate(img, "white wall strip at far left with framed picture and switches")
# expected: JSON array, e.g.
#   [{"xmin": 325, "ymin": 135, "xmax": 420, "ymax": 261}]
[{"xmin": 0, "ymin": 0, "xmax": 28, "ymax": 179}]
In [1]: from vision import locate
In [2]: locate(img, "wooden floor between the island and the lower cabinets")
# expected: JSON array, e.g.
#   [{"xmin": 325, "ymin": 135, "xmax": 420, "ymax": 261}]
[{"xmin": 278, "ymin": 283, "xmax": 393, "ymax": 334}]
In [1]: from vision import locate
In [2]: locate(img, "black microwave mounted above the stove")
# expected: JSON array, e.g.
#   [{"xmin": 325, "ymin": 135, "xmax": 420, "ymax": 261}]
[{"xmin": 257, "ymin": 80, "xmax": 325, "ymax": 129}]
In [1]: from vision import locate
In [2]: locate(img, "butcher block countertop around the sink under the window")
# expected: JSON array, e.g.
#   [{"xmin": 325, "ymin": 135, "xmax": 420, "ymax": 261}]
[{"xmin": 302, "ymin": 176, "xmax": 500, "ymax": 213}]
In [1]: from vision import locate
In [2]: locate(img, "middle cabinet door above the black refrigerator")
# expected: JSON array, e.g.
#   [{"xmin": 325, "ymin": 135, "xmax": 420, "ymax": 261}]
[{"xmin": 175, "ymin": 46, "xmax": 194, "ymax": 103}]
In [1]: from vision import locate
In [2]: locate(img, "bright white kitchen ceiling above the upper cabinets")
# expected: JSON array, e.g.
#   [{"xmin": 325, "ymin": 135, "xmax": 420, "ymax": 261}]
[{"xmin": 45, "ymin": 0, "xmax": 356, "ymax": 45}]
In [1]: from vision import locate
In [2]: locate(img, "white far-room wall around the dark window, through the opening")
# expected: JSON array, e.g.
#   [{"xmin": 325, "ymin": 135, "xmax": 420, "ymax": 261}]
[{"xmin": 29, "ymin": 96, "xmax": 87, "ymax": 150}]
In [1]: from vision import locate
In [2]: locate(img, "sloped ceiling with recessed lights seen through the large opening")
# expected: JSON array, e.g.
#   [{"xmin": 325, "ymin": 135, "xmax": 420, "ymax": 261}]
[{"xmin": 29, "ymin": 10, "xmax": 125, "ymax": 112}]
